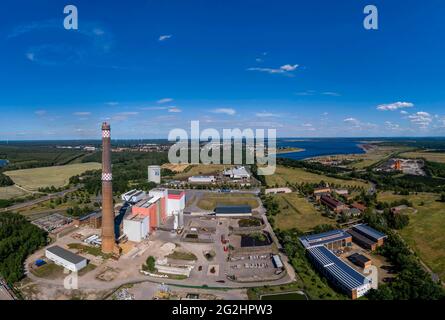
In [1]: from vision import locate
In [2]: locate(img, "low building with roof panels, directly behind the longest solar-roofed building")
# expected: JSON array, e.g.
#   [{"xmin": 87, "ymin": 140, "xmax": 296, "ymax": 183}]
[{"xmin": 300, "ymin": 230, "xmax": 352, "ymax": 250}]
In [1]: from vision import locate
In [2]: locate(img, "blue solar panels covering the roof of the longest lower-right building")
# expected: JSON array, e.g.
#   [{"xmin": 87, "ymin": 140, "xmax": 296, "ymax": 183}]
[{"xmin": 308, "ymin": 246, "xmax": 370, "ymax": 290}]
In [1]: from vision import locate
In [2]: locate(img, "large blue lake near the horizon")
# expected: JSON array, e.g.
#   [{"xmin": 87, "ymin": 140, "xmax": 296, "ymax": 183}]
[{"xmin": 277, "ymin": 138, "xmax": 365, "ymax": 160}]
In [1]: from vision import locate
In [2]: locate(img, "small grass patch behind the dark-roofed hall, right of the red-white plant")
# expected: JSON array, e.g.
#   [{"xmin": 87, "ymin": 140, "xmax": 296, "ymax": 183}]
[{"xmin": 197, "ymin": 193, "xmax": 259, "ymax": 210}]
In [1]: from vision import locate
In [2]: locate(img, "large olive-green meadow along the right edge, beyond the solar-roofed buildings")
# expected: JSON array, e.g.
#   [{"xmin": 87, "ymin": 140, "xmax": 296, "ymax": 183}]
[{"xmin": 378, "ymin": 192, "xmax": 445, "ymax": 281}]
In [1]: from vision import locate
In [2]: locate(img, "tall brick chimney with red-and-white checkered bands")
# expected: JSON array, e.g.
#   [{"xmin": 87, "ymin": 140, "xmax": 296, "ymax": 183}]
[{"xmin": 102, "ymin": 122, "xmax": 116, "ymax": 253}]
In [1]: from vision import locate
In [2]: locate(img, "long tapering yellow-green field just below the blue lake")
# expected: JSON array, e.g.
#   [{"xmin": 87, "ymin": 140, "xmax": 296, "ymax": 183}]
[{"xmin": 266, "ymin": 166, "xmax": 370, "ymax": 189}]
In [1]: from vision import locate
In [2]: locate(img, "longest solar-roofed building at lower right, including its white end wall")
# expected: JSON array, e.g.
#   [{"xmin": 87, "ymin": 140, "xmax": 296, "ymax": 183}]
[{"xmin": 307, "ymin": 246, "xmax": 371, "ymax": 299}]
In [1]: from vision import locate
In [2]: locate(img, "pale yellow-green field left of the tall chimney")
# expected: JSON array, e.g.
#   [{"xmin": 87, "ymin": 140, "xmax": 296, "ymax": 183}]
[{"xmin": 4, "ymin": 162, "xmax": 101, "ymax": 191}]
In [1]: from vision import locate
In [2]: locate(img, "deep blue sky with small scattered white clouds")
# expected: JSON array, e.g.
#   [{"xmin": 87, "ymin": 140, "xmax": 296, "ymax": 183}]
[{"xmin": 0, "ymin": 0, "xmax": 445, "ymax": 140}]
